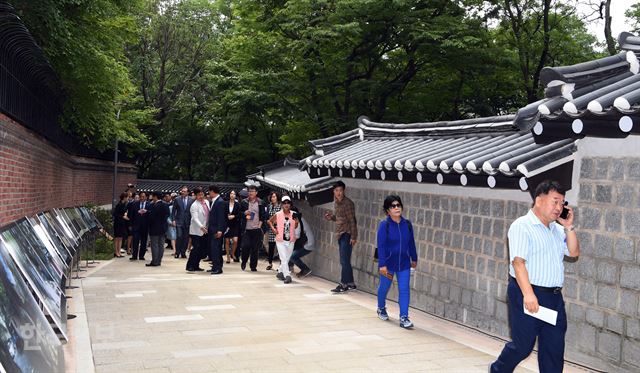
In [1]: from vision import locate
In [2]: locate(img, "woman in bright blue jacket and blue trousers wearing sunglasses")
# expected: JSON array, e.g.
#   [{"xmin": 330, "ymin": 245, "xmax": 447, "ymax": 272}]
[{"xmin": 378, "ymin": 195, "xmax": 418, "ymax": 328}]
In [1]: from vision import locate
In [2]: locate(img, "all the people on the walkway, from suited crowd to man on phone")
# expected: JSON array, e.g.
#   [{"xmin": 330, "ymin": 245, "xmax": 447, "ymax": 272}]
[{"xmin": 113, "ymin": 181, "xmax": 580, "ymax": 372}]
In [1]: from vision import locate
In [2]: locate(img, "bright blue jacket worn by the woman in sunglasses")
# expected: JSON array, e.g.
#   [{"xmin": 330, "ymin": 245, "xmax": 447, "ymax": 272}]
[{"xmin": 378, "ymin": 216, "xmax": 418, "ymax": 273}]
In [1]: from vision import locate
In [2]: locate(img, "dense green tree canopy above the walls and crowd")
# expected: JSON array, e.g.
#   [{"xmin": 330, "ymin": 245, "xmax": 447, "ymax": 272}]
[{"xmin": 14, "ymin": 0, "xmax": 640, "ymax": 181}]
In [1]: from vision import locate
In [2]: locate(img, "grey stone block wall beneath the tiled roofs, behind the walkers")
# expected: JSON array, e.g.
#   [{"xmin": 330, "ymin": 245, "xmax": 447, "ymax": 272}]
[{"xmin": 303, "ymin": 159, "xmax": 640, "ymax": 372}]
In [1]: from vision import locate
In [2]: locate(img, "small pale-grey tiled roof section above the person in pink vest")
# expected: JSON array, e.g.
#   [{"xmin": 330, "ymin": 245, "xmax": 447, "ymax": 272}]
[{"xmin": 247, "ymin": 158, "xmax": 334, "ymax": 206}]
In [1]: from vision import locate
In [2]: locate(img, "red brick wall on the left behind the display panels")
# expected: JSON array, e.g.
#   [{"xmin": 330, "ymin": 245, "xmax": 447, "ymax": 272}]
[{"xmin": 0, "ymin": 114, "xmax": 136, "ymax": 226}]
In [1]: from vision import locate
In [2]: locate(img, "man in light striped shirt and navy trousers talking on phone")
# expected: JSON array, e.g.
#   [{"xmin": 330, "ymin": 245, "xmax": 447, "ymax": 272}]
[{"xmin": 489, "ymin": 181, "xmax": 580, "ymax": 373}]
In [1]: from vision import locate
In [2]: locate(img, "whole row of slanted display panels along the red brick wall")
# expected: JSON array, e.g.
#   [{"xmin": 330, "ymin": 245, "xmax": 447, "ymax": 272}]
[{"xmin": 0, "ymin": 207, "xmax": 102, "ymax": 372}]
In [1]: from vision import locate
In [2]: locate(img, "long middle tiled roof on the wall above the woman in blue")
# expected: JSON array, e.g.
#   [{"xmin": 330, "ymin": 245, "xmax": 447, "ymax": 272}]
[{"xmin": 304, "ymin": 115, "xmax": 576, "ymax": 190}]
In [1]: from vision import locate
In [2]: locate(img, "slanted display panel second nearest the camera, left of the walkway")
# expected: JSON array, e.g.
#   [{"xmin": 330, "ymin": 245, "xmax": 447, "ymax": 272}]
[{"xmin": 0, "ymin": 224, "xmax": 68, "ymax": 340}]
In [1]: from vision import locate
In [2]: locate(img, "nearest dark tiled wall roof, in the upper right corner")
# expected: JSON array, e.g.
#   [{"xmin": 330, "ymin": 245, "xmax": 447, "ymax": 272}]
[{"xmin": 515, "ymin": 32, "xmax": 640, "ymax": 141}]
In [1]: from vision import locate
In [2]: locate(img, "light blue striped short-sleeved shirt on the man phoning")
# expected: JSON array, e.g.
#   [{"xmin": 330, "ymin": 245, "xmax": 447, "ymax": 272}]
[{"xmin": 508, "ymin": 210, "xmax": 569, "ymax": 287}]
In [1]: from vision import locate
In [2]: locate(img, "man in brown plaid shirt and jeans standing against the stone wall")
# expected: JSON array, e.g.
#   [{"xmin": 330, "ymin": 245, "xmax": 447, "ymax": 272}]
[{"xmin": 324, "ymin": 181, "xmax": 358, "ymax": 294}]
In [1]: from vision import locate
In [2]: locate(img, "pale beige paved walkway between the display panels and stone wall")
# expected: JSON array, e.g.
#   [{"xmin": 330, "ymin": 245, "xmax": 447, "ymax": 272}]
[{"xmin": 66, "ymin": 256, "xmax": 588, "ymax": 373}]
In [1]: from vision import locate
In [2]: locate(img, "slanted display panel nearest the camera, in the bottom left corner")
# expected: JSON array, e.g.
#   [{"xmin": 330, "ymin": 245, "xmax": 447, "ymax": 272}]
[{"xmin": 0, "ymin": 240, "xmax": 64, "ymax": 372}]
